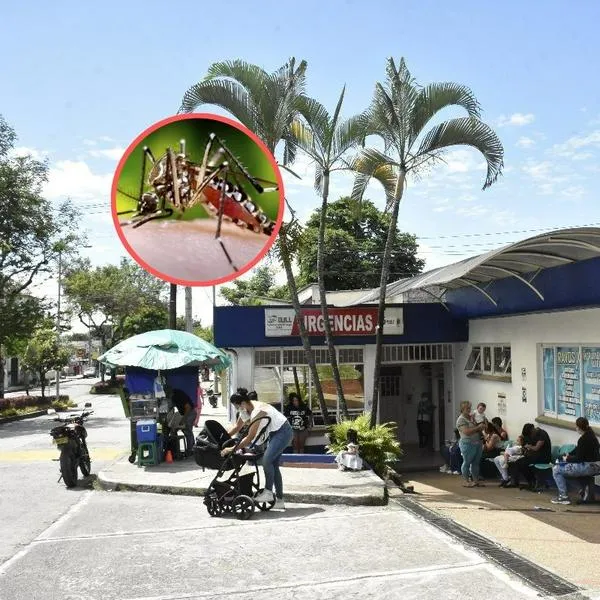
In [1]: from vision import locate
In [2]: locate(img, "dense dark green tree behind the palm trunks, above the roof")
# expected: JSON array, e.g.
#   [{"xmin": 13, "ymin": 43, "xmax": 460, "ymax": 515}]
[{"xmin": 297, "ymin": 197, "xmax": 425, "ymax": 291}]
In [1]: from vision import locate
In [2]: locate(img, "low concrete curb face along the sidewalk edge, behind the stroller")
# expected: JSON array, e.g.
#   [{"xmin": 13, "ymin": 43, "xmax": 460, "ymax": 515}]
[{"xmin": 96, "ymin": 472, "xmax": 388, "ymax": 506}]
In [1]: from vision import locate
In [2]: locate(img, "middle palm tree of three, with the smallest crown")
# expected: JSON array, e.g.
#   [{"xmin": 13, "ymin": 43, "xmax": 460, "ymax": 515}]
[{"xmin": 292, "ymin": 86, "xmax": 365, "ymax": 419}]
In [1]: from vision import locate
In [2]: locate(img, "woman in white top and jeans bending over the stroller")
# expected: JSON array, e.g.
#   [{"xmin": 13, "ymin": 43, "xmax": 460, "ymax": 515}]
[{"xmin": 221, "ymin": 392, "xmax": 294, "ymax": 509}]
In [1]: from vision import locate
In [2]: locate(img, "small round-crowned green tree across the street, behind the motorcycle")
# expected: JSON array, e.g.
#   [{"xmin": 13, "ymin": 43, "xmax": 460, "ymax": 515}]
[{"xmin": 21, "ymin": 319, "xmax": 71, "ymax": 400}]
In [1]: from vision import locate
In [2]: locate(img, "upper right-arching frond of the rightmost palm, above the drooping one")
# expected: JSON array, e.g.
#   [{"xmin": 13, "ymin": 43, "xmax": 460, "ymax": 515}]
[{"xmin": 409, "ymin": 82, "xmax": 481, "ymax": 144}]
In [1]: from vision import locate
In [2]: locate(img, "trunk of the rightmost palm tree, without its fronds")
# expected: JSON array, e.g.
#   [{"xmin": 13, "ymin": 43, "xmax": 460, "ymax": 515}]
[{"xmin": 370, "ymin": 170, "xmax": 406, "ymax": 429}]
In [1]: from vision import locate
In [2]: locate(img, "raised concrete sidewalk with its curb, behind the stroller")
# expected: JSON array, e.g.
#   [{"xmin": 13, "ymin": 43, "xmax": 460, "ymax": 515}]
[{"xmin": 98, "ymin": 456, "xmax": 387, "ymax": 506}]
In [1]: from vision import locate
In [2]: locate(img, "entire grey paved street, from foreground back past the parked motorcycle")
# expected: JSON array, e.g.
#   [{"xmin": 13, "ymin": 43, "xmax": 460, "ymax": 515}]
[{"xmin": 0, "ymin": 381, "xmax": 588, "ymax": 600}]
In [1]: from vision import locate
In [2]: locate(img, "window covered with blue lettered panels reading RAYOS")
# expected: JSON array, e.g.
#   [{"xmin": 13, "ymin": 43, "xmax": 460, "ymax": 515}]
[{"xmin": 541, "ymin": 345, "xmax": 600, "ymax": 424}]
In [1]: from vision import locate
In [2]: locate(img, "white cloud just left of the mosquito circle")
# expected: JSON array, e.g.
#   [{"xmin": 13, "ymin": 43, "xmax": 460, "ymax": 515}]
[{"xmin": 44, "ymin": 160, "xmax": 113, "ymax": 206}]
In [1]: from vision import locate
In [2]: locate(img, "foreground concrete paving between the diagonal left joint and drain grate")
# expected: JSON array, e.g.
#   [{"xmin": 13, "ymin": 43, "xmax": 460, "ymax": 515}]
[{"xmin": 0, "ymin": 491, "xmax": 535, "ymax": 600}]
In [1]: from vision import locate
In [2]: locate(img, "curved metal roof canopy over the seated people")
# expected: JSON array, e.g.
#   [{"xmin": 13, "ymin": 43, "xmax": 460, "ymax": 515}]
[{"xmin": 353, "ymin": 227, "xmax": 600, "ymax": 304}]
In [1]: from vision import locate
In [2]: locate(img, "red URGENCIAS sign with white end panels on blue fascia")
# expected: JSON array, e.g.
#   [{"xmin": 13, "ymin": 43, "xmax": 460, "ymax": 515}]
[{"xmin": 265, "ymin": 307, "xmax": 404, "ymax": 337}]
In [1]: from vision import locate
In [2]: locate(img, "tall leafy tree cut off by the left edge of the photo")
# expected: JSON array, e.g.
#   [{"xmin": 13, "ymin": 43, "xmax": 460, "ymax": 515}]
[{"xmin": 0, "ymin": 116, "xmax": 78, "ymax": 398}]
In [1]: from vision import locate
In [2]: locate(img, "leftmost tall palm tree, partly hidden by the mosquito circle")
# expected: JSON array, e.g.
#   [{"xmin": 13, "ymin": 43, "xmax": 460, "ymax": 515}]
[{"xmin": 179, "ymin": 58, "xmax": 329, "ymax": 425}]
